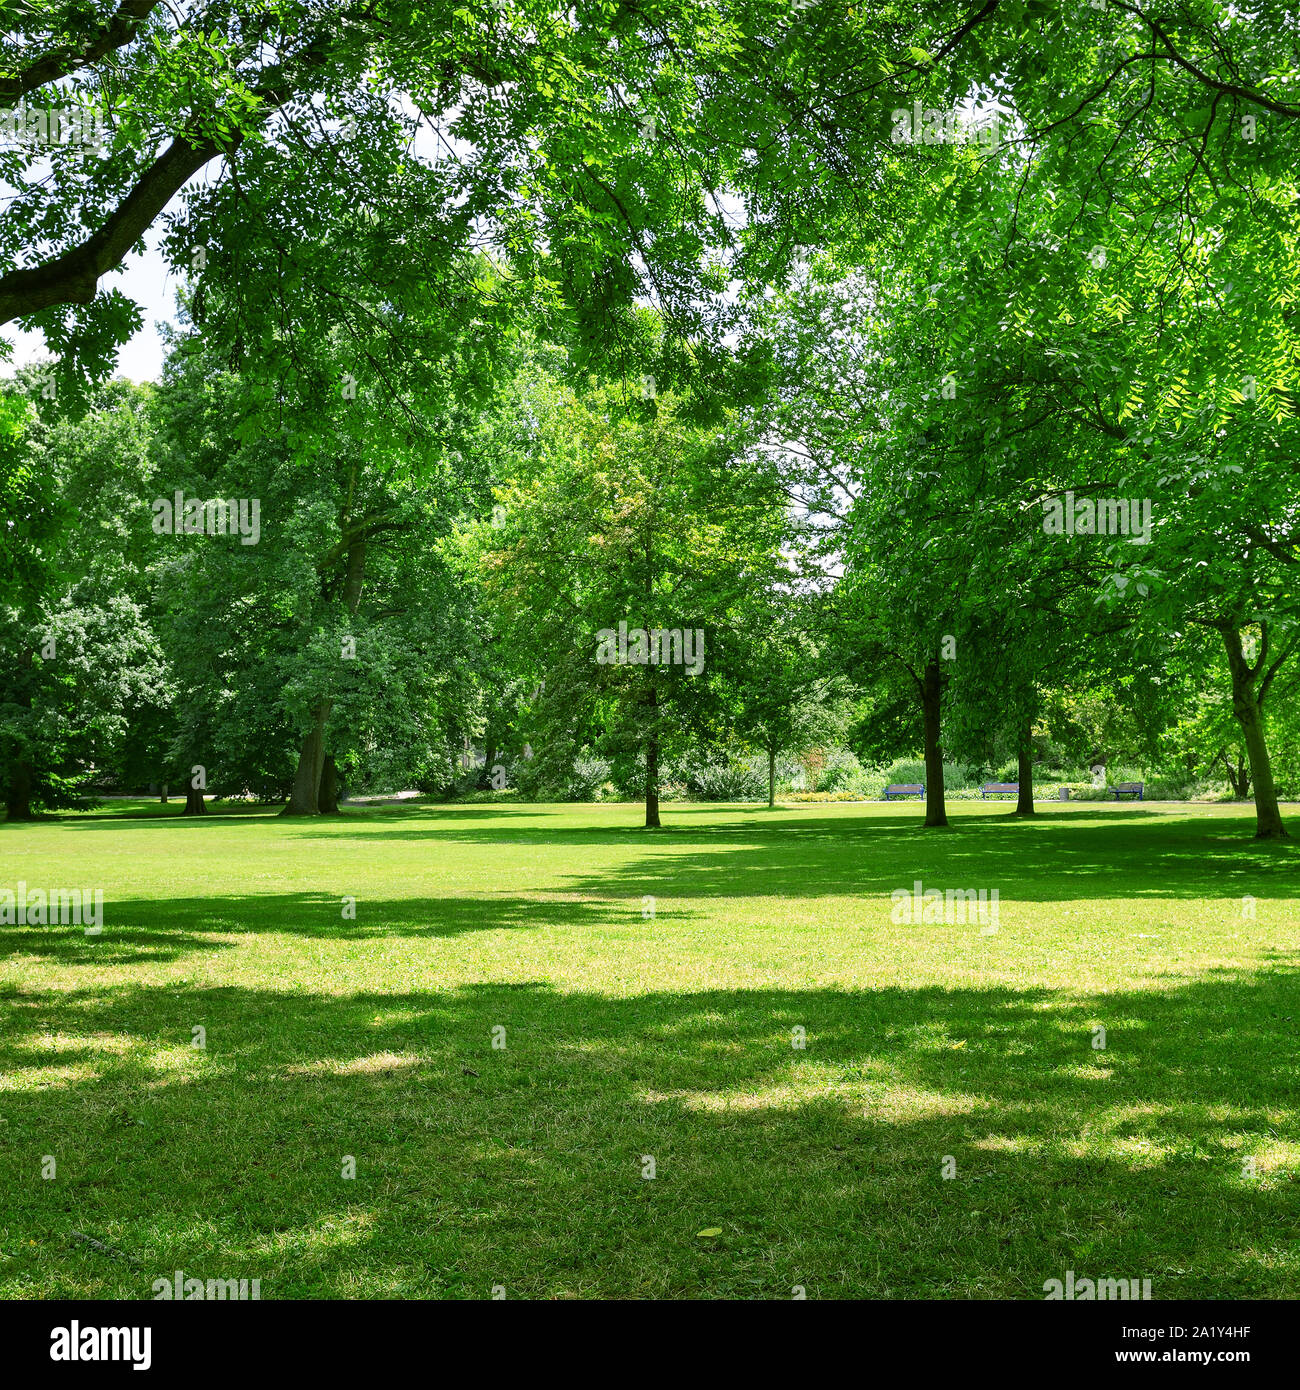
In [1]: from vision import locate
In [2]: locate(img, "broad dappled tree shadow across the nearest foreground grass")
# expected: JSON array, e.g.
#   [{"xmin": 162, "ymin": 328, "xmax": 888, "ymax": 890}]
[{"xmin": 0, "ymin": 954, "xmax": 1300, "ymax": 1298}]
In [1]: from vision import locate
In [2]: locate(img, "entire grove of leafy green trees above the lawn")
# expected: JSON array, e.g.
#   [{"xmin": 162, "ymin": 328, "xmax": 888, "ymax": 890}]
[{"xmin": 0, "ymin": 0, "xmax": 1300, "ymax": 840}]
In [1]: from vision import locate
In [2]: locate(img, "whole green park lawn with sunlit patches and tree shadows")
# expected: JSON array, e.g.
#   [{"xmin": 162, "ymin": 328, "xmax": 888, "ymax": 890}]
[{"xmin": 0, "ymin": 802, "xmax": 1300, "ymax": 1298}]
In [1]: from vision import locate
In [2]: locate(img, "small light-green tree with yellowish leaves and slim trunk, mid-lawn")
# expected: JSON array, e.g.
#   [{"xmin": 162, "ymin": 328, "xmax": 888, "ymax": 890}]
[{"xmin": 467, "ymin": 378, "xmax": 784, "ymax": 828}]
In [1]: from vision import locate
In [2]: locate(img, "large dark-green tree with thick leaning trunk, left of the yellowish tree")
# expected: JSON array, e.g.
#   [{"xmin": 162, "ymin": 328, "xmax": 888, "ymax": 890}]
[{"xmin": 154, "ymin": 326, "xmax": 489, "ymax": 816}]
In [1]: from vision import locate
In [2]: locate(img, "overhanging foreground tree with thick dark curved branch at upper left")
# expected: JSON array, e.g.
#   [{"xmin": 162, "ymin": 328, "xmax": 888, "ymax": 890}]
[{"xmin": 0, "ymin": 0, "xmax": 984, "ymax": 381}]
